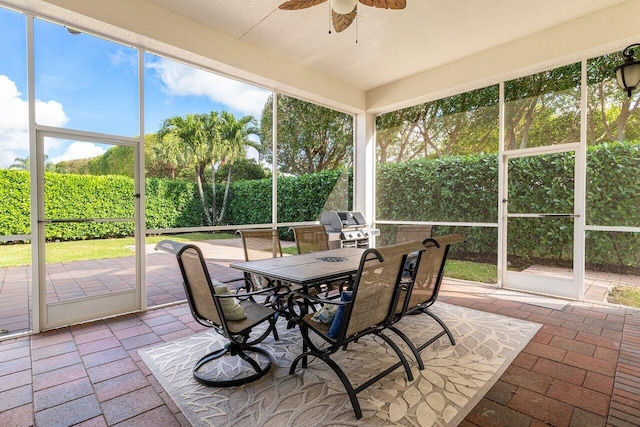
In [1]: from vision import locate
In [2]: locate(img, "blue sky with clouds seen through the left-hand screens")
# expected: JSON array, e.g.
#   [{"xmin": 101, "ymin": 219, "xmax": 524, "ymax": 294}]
[{"xmin": 0, "ymin": 8, "xmax": 271, "ymax": 168}]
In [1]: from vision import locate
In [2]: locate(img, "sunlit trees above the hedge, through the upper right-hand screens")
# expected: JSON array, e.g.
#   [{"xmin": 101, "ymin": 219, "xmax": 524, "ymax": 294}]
[{"xmin": 376, "ymin": 54, "xmax": 640, "ymax": 163}]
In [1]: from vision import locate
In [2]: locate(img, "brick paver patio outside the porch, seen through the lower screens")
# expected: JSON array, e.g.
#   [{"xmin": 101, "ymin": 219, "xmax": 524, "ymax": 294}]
[{"xmin": 0, "ymin": 238, "xmax": 640, "ymax": 338}]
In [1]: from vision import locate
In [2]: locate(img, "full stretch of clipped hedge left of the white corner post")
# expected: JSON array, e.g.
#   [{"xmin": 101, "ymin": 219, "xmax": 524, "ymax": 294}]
[{"xmin": 0, "ymin": 170, "xmax": 351, "ymax": 240}]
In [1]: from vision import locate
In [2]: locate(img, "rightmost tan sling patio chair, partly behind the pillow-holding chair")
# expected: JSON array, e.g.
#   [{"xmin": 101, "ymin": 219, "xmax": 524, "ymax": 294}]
[{"xmin": 389, "ymin": 234, "xmax": 466, "ymax": 370}]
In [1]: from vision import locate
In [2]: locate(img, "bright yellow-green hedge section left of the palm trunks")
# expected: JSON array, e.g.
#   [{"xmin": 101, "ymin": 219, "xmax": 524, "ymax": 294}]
[{"xmin": 0, "ymin": 170, "xmax": 204, "ymax": 240}]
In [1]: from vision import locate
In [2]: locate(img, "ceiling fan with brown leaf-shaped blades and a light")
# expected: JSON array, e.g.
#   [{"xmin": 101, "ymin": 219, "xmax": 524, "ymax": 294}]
[{"xmin": 279, "ymin": 0, "xmax": 407, "ymax": 33}]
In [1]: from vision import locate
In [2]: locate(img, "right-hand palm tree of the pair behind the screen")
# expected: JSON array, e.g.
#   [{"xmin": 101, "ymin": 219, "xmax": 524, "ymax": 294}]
[{"xmin": 212, "ymin": 111, "xmax": 260, "ymax": 223}]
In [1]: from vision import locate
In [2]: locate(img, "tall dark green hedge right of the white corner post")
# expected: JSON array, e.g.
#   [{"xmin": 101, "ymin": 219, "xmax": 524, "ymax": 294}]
[{"xmin": 376, "ymin": 142, "xmax": 640, "ymax": 269}]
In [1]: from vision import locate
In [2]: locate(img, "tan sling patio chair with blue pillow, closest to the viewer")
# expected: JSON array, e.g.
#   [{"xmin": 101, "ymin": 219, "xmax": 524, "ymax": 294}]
[{"xmin": 288, "ymin": 241, "xmax": 424, "ymax": 419}]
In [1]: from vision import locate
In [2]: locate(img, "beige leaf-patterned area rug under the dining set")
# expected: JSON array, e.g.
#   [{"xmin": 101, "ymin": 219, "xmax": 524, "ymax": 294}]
[{"xmin": 140, "ymin": 303, "xmax": 541, "ymax": 426}]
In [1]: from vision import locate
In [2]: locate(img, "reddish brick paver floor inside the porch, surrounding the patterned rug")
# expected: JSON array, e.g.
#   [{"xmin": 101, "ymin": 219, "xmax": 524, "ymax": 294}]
[{"xmin": 0, "ymin": 281, "xmax": 640, "ymax": 427}]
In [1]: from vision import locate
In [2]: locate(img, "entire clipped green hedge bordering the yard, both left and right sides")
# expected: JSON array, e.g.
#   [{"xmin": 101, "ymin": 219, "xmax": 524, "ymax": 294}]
[{"xmin": 0, "ymin": 142, "xmax": 640, "ymax": 268}]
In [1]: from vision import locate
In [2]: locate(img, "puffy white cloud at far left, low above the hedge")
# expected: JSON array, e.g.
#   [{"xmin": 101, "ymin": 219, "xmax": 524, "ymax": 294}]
[{"xmin": 0, "ymin": 75, "xmax": 69, "ymax": 168}]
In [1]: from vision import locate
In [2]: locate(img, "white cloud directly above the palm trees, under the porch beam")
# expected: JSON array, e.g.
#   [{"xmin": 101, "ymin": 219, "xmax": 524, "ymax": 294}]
[{"xmin": 147, "ymin": 58, "xmax": 271, "ymax": 119}]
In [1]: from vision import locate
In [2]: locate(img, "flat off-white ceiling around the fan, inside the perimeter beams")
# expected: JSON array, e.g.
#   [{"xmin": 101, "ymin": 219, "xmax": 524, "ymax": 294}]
[{"xmin": 142, "ymin": 0, "xmax": 627, "ymax": 91}]
